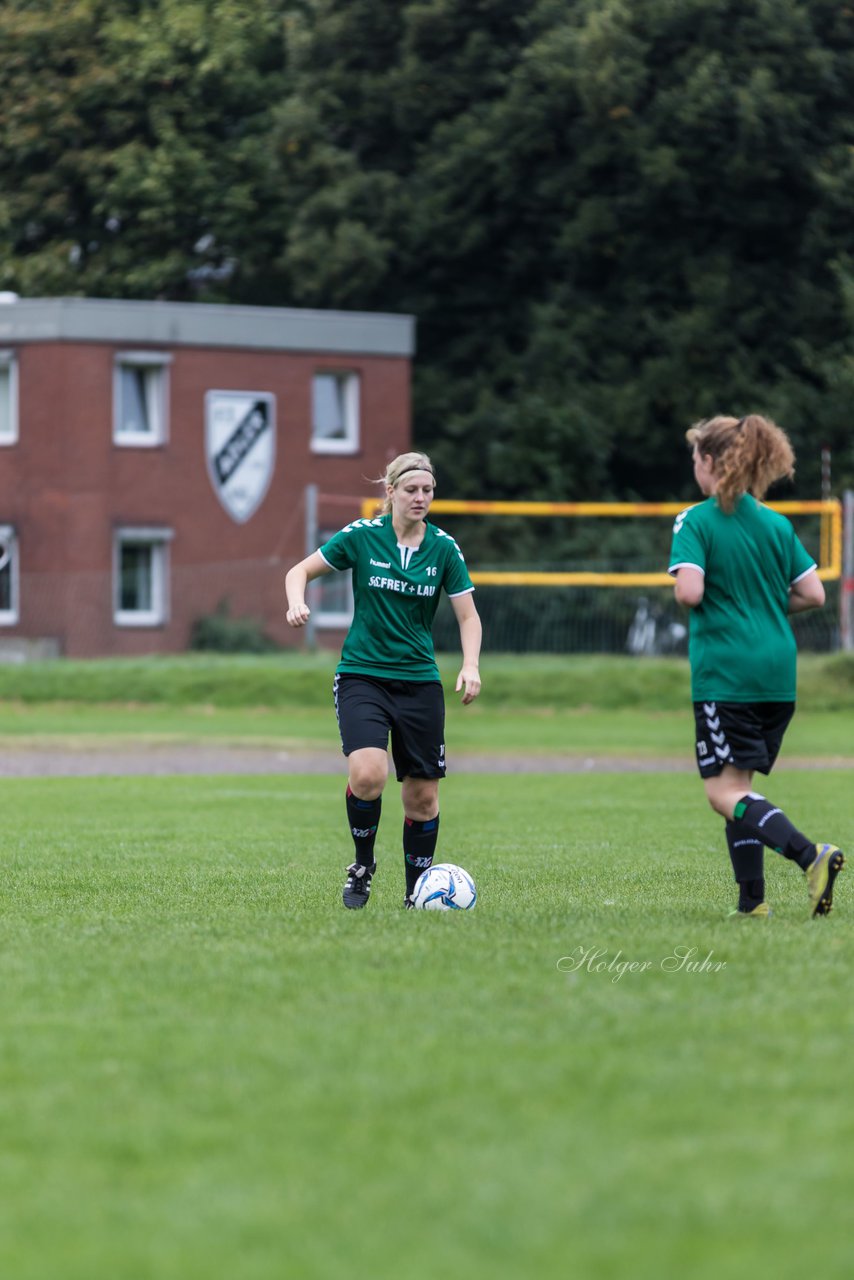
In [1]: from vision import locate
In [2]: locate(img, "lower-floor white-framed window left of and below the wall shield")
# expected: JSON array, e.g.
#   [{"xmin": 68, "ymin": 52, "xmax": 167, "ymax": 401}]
[{"xmin": 113, "ymin": 529, "xmax": 173, "ymax": 627}]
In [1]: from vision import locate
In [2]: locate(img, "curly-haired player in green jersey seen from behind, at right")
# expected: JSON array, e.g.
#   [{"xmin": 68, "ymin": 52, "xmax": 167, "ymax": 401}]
[{"xmin": 670, "ymin": 413, "xmax": 845, "ymax": 919}]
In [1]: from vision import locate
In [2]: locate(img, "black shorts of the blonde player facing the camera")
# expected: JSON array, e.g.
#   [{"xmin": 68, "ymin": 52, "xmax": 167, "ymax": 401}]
[{"xmin": 333, "ymin": 675, "xmax": 444, "ymax": 782}]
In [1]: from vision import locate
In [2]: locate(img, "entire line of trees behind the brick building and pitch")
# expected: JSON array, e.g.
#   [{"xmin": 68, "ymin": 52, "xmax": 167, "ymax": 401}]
[{"xmin": 0, "ymin": 0, "xmax": 854, "ymax": 517}]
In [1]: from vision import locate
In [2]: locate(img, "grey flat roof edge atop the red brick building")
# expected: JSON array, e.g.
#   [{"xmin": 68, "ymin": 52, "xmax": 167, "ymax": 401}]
[{"xmin": 0, "ymin": 298, "xmax": 415, "ymax": 356}]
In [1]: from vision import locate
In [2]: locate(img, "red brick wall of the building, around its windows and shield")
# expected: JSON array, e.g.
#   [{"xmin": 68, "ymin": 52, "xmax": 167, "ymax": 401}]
[{"xmin": 0, "ymin": 334, "xmax": 411, "ymax": 657}]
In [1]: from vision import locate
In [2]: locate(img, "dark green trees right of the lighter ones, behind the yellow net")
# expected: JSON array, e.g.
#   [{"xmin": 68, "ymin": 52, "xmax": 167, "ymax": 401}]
[{"xmin": 270, "ymin": 0, "xmax": 854, "ymax": 498}]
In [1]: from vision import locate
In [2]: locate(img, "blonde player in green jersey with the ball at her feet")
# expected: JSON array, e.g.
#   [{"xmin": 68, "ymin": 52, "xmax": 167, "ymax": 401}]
[{"xmin": 286, "ymin": 453, "xmax": 481, "ymax": 909}]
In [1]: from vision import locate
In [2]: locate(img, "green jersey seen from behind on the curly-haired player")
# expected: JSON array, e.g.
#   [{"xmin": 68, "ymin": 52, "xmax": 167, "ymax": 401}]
[{"xmin": 668, "ymin": 494, "xmax": 816, "ymax": 703}]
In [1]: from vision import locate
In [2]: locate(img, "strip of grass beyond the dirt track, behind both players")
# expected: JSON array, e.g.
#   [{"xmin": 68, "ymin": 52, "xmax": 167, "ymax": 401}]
[{"xmin": 0, "ymin": 653, "xmax": 854, "ymax": 763}]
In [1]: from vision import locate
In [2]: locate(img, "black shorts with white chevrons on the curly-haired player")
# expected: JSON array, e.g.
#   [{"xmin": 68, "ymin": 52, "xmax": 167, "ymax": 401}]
[{"xmin": 694, "ymin": 703, "xmax": 795, "ymax": 778}]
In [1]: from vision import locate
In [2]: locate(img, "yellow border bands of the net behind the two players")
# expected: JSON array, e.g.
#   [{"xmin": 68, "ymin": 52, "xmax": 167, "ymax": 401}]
[{"xmin": 361, "ymin": 498, "xmax": 842, "ymax": 586}]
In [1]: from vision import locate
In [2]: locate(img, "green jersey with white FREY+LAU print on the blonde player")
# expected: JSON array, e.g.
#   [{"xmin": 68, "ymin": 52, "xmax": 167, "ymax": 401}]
[{"xmin": 320, "ymin": 513, "xmax": 474, "ymax": 680}]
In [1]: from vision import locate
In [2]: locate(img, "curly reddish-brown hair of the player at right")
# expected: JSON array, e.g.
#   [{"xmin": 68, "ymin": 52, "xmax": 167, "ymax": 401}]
[{"xmin": 685, "ymin": 413, "xmax": 795, "ymax": 512}]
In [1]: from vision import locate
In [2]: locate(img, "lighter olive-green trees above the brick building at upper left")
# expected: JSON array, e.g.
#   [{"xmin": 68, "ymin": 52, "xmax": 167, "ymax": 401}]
[{"xmin": 0, "ymin": 0, "xmax": 284, "ymax": 298}]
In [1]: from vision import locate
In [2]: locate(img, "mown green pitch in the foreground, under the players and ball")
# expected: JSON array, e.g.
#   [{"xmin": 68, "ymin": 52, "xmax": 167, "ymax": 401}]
[{"xmin": 0, "ymin": 771, "xmax": 854, "ymax": 1280}]
